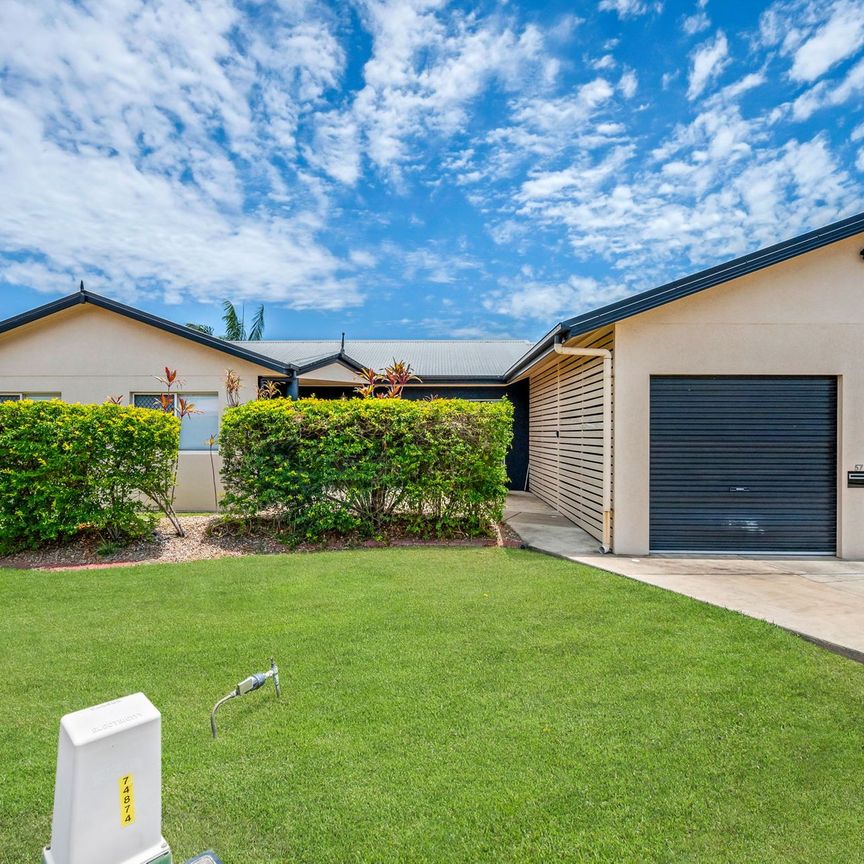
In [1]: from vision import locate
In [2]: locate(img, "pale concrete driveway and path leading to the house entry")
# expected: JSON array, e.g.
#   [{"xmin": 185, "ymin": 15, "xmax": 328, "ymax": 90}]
[{"xmin": 504, "ymin": 493, "xmax": 864, "ymax": 662}]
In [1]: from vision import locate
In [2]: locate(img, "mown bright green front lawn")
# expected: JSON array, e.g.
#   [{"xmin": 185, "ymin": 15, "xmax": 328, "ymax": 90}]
[{"xmin": 0, "ymin": 549, "xmax": 864, "ymax": 864}]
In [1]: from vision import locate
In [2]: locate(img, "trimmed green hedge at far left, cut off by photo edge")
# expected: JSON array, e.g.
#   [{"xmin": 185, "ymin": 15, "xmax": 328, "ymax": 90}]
[{"xmin": 0, "ymin": 400, "xmax": 180, "ymax": 552}]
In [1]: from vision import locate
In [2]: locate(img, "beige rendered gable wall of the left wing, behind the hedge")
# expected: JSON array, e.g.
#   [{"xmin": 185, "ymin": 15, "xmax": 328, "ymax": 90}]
[{"xmin": 0, "ymin": 304, "xmax": 274, "ymax": 510}]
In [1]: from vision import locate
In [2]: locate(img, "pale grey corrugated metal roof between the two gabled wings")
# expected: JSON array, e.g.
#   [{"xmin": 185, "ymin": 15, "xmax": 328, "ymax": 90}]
[{"xmin": 234, "ymin": 339, "xmax": 531, "ymax": 383}]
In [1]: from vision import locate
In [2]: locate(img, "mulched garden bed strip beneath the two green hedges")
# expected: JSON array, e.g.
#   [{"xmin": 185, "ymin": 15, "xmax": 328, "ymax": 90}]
[{"xmin": 0, "ymin": 515, "xmax": 522, "ymax": 570}]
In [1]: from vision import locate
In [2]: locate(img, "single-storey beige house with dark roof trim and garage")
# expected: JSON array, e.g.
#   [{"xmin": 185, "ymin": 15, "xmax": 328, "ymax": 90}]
[{"xmin": 0, "ymin": 214, "xmax": 864, "ymax": 559}]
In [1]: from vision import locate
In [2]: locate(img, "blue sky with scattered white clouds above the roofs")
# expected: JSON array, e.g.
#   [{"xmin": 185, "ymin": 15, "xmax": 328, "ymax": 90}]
[{"xmin": 0, "ymin": 0, "xmax": 864, "ymax": 338}]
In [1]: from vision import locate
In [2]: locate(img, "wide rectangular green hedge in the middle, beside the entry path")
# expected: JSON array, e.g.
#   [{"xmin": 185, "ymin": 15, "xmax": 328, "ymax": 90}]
[{"xmin": 219, "ymin": 399, "xmax": 513, "ymax": 539}]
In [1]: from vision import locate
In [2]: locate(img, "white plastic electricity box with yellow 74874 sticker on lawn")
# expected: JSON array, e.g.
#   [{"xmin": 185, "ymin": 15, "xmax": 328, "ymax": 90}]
[{"xmin": 42, "ymin": 693, "xmax": 171, "ymax": 864}]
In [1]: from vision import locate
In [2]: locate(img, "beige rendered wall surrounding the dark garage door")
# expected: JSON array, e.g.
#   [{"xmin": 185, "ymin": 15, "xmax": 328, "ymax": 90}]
[{"xmin": 613, "ymin": 237, "xmax": 864, "ymax": 559}]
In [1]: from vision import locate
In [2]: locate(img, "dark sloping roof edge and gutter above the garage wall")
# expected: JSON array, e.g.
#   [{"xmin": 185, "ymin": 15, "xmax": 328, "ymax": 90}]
[{"xmin": 505, "ymin": 213, "xmax": 864, "ymax": 379}]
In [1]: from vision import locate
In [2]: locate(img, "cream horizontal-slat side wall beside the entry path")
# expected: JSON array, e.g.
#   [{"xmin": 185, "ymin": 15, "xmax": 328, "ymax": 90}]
[{"xmin": 528, "ymin": 327, "xmax": 617, "ymax": 540}]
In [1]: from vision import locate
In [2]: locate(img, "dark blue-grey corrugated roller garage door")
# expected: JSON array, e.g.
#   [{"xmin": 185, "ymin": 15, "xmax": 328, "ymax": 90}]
[{"xmin": 650, "ymin": 376, "xmax": 837, "ymax": 554}]
